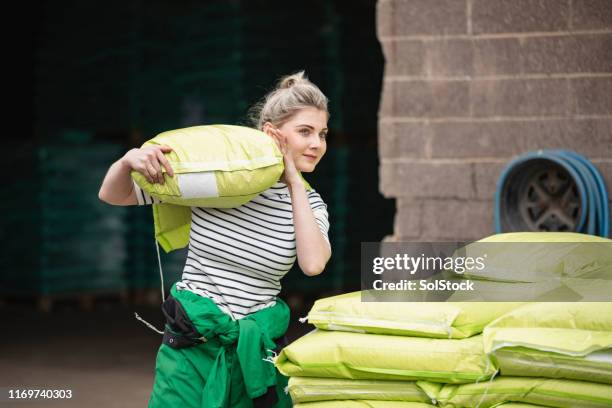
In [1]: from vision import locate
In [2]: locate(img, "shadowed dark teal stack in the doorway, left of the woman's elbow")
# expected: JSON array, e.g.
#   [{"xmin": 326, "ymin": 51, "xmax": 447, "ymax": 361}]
[{"xmin": 38, "ymin": 143, "xmax": 127, "ymax": 295}]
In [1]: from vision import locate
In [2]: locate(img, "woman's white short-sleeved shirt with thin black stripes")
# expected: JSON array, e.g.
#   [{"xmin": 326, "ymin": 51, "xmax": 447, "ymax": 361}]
[{"xmin": 134, "ymin": 182, "xmax": 329, "ymax": 319}]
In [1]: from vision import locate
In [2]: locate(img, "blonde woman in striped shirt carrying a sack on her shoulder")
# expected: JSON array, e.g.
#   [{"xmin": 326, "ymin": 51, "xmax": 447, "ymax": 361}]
[{"xmin": 99, "ymin": 72, "xmax": 331, "ymax": 407}]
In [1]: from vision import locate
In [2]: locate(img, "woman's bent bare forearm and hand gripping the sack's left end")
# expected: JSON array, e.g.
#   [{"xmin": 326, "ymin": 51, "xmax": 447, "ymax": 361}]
[{"xmin": 98, "ymin": 146, "xmax": 173, "ymax": 205}]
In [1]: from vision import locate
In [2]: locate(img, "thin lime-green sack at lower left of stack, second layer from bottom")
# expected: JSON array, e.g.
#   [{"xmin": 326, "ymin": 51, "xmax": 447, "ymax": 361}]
[{"xmin": 287, "ymin": 377, "xmax": 431, "ymax": 404}]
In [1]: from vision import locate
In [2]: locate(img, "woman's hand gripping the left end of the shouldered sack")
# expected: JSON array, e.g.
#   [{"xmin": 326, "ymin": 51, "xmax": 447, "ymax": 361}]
[{"xmin": 122, "ymin": 145, "xmax": 174, "ymax": 184}]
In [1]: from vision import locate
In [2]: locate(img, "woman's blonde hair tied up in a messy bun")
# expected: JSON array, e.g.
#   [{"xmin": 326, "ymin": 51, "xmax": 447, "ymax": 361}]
[{"xmin": 249, "ymin": 71, "xmax": 329, "ymax": 130}]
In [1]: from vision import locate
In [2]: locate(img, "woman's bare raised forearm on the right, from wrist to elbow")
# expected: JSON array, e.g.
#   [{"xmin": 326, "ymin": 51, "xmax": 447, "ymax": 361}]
[{"xmin": 287, "ymin": 179, "xmax": 331, "ymax": 276}]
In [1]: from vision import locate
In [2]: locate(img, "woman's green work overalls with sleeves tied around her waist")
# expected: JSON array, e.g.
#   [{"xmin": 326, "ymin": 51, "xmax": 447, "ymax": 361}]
[{"xmin": 149, "ymin": 286, "xmax": 291, "ymax": 408}]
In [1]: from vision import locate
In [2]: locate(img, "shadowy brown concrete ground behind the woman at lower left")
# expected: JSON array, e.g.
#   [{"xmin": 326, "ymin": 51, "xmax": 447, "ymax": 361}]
[{"xmin": 0, "ymin": 296, "xmax": 312, "ymax": 408}]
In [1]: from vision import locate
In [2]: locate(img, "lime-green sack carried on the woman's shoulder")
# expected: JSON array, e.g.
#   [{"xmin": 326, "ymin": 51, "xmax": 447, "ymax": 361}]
[{"xmin": 131, "ymin": 125, "xmax": 284, "ymax": 252}]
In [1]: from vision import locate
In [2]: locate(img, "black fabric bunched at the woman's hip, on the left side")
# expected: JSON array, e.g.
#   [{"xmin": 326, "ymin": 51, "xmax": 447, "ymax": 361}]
[{"xmin": 162, "ymin": 295, "xmax": 204, "ymax": 349}]
